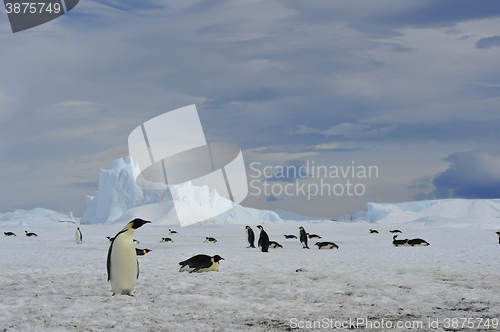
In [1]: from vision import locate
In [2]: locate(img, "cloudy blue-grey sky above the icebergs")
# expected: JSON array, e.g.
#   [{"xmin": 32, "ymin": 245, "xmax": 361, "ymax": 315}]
[{"xmin": 0, "ymin": 0, "xmax": 500, "ymax": 218}]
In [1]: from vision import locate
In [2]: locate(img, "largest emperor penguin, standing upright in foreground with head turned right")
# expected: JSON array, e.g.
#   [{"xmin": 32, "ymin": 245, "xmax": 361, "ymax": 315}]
[{"xmin": 107, "ymin": 219, "xmax": 150, "ymax": 296}]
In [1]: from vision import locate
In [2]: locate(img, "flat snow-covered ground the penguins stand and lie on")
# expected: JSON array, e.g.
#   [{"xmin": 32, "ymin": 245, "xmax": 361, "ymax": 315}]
[{"xmin": 0, "ymin": 206, "xmax": 500, "ymax": 331}]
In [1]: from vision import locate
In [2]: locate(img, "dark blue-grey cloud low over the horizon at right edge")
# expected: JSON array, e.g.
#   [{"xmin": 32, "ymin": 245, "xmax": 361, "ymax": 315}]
[{"xmin": 415, "ymin": 150, "xmax": 500, "ymax": 200}]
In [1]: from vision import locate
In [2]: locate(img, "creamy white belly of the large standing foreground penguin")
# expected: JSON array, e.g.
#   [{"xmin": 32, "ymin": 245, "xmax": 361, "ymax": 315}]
[{"xmin": 110, "ymin": 234, "xmax": 137, "ymax": 295}]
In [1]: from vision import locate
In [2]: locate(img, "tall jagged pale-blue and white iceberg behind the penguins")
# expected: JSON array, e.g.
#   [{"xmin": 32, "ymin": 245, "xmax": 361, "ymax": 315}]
[{"xmin": 81, "ymin": 157, "xmax": 281, "ymax": 225}]
